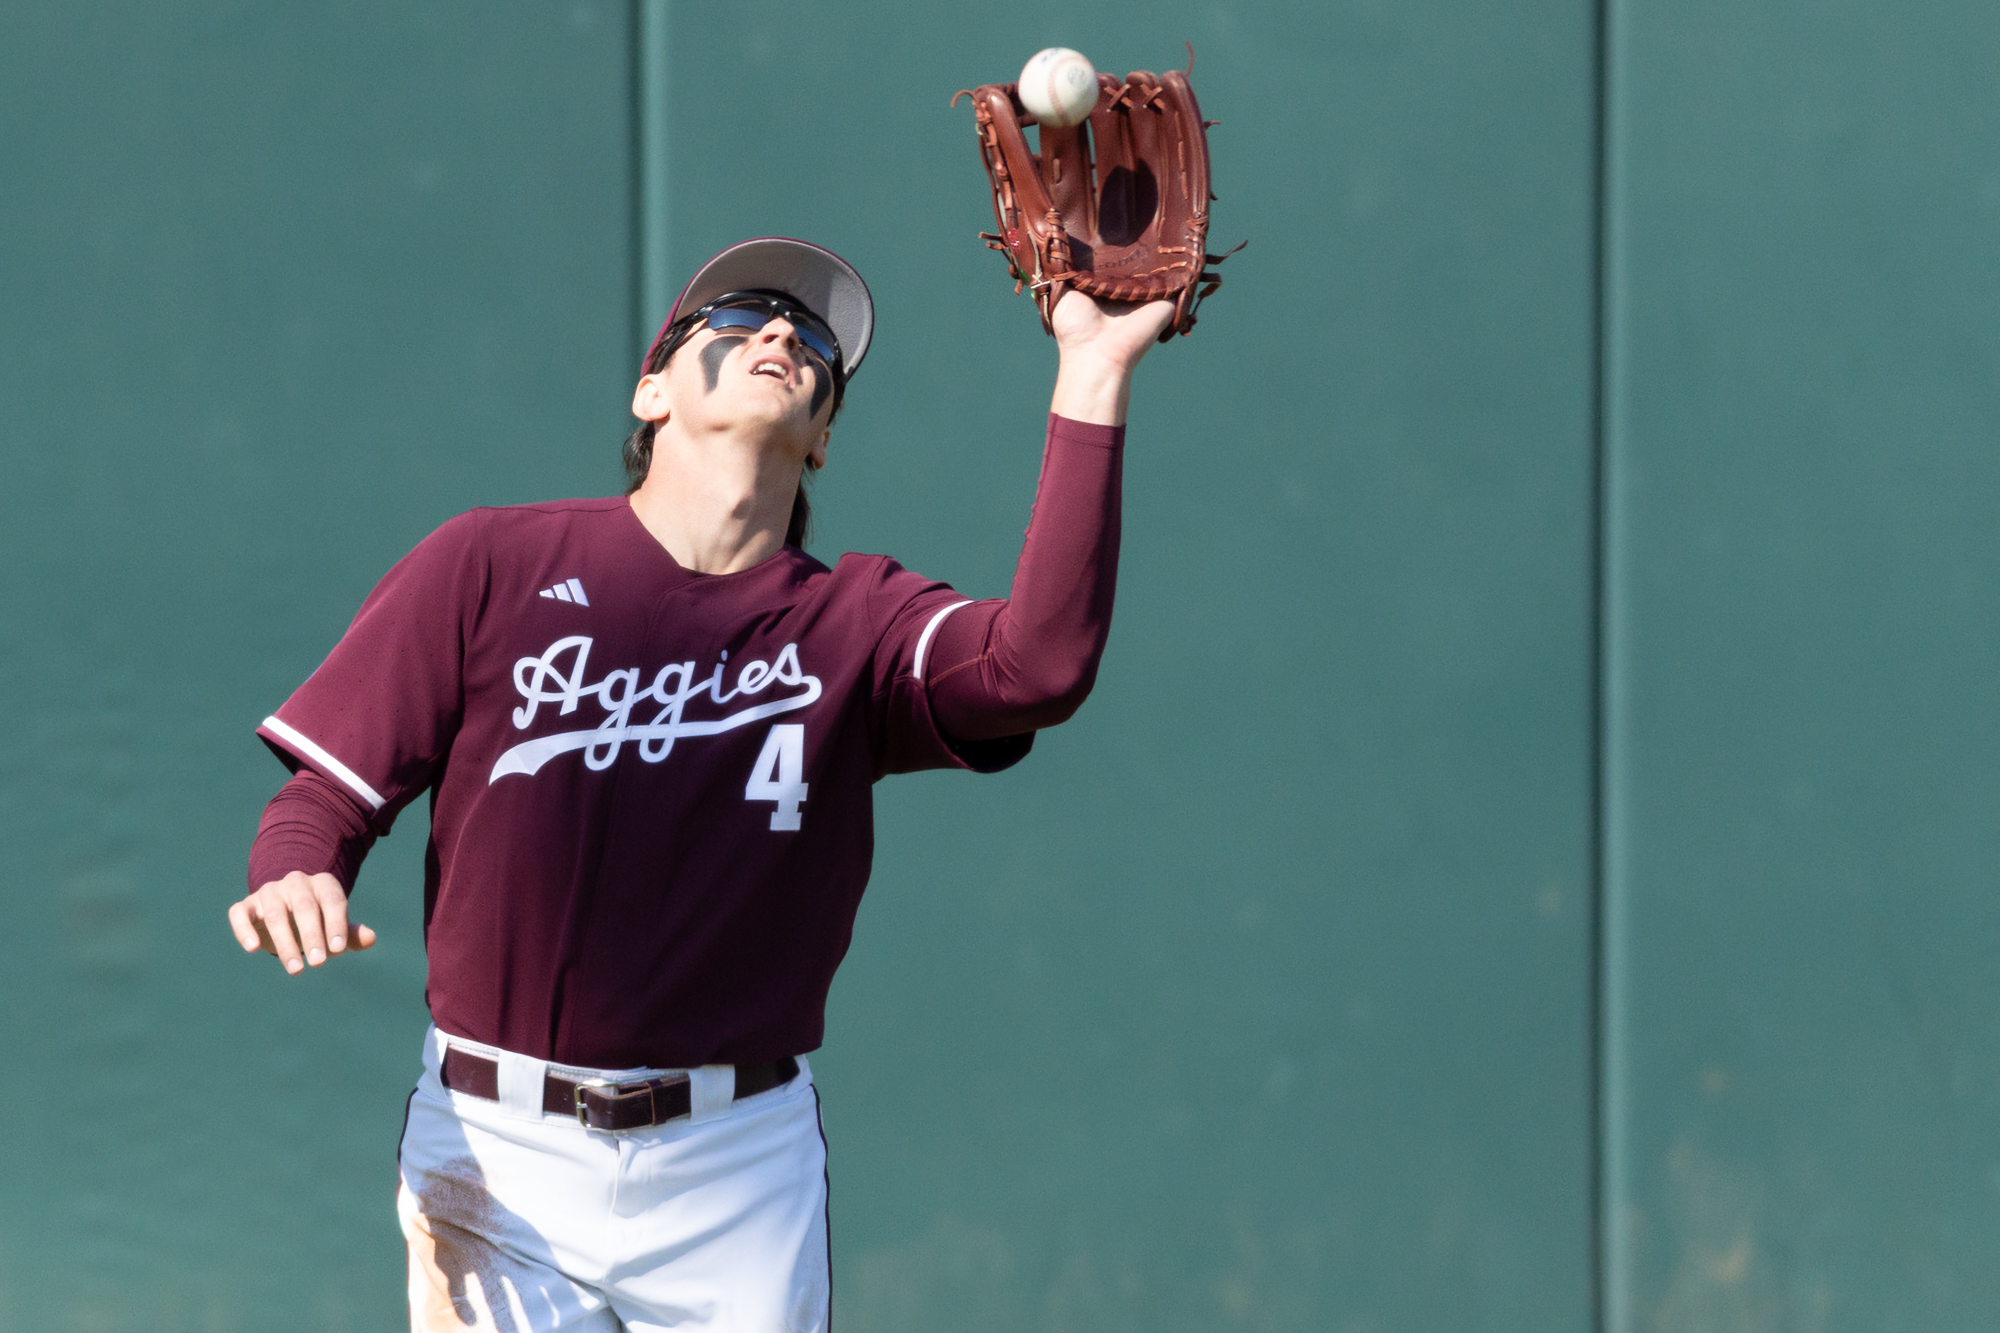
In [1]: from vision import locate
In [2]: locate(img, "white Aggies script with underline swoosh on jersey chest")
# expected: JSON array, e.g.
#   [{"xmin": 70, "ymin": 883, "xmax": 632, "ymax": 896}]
[{"xmin": 486, "ymin": 634, "xmax": 820, "ymax": 785}]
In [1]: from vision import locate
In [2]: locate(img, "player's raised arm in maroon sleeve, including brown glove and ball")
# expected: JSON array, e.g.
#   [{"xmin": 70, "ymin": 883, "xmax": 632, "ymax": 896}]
[{"xmin": 936, "ymin": 48, "xmax": 1242, "ymax": 736}]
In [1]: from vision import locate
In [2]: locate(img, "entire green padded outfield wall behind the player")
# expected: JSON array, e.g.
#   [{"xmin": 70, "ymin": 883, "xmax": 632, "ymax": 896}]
[{"xmin": 0, "ymin": 0, "xmax": 2000, "ymax": 1333}]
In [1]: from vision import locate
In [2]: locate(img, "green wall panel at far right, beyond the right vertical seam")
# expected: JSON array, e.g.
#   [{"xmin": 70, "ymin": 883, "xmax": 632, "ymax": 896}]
[{"xmin": 1604, "ymin": 0, "xmax": 2000, "ymax": 1331}]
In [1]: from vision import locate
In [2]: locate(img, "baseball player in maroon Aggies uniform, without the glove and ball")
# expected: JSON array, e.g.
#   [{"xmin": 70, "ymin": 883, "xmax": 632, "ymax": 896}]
[{"xmin": 228, "ymin": 238, "xmax": 1172, "ymax": 1333}]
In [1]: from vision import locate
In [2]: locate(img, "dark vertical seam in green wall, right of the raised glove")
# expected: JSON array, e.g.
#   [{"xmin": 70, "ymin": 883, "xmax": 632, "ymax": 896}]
[{"xmin": 1588, "ymin": 0, "xmax": 1614, "ymax": 1333}]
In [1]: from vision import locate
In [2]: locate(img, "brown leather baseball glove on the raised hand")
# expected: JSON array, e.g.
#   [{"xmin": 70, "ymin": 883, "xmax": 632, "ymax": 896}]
[{"xmin": 952, "ymin": 46, "xmax": 1242, "ymax": 342}]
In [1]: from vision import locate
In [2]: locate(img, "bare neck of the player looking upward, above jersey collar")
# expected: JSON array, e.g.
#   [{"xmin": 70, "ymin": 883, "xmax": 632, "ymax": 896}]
[{"xmin": 632, "ymin": 420, "xmax": 802, "ymax": 574}]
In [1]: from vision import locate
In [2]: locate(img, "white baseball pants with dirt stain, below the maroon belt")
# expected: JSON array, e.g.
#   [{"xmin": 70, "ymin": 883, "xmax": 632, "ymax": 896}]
[{"xmin": 396, "ymin": 1029, "xmax": 830, "ymax": 1333}]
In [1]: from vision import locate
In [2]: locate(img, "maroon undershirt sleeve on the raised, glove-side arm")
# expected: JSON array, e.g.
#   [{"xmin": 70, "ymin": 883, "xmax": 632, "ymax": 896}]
[{"xmin": 926, "ymin": 416, "xmax": 1124, "ymax": 743}]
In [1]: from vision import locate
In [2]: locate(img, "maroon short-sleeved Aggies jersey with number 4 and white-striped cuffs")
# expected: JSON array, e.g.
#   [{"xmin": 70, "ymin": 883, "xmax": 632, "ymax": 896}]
[{"xmin": 258, "ymin": 498, "xmax": 1028, "ymax": 1067}]
